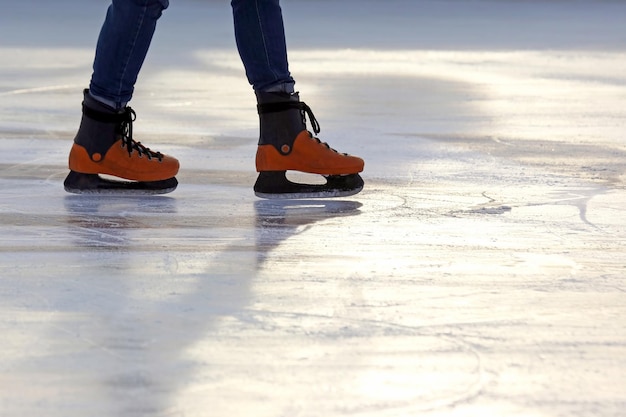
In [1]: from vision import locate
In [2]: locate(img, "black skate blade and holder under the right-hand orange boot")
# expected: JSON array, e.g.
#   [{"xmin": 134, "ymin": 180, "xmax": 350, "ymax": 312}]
[{"xmin": 254, "ymin": 171, "xmax": 364, "ymax": 199}]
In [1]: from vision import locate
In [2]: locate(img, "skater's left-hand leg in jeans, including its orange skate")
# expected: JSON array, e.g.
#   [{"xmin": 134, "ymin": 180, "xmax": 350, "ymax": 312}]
[{"xmin": 65, "ymin": 0, "xmax": 179, "ymax": 194}]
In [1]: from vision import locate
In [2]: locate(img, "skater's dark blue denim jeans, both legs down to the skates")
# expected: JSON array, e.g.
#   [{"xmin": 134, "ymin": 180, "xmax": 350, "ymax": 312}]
[{"xmin": 89, "ymin": 0, "xmax": 294, "ymax": 108}]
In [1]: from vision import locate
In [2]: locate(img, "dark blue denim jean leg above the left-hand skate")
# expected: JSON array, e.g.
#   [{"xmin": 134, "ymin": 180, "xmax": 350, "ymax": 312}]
[{"xmin": 89, "ymin": 0, "xmax": 169, "ymax": 108}]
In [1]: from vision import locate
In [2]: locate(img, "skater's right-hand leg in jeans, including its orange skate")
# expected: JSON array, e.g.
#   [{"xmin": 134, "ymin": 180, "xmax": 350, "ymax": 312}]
[{"xmin": 231, "ymin": 0, "xmax": 364, "ymax": 198}]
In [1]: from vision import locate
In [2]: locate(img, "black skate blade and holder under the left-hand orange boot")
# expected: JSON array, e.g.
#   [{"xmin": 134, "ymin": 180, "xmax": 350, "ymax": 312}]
[{"xmin": 63, "ymin": 171, "xmax": 178, "ymax": 195}]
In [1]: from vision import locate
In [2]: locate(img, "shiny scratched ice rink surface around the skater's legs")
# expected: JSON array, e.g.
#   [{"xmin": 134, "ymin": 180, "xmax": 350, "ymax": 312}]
[{"xmin": 0, "ymin": 0, "xmax": 626, "ymax": 417}]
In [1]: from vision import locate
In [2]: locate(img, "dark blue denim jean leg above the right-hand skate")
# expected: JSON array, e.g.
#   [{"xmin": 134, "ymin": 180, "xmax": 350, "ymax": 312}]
[{"xmin": 231, "ymin": 0, "xmax": 294, "ymax": 91}]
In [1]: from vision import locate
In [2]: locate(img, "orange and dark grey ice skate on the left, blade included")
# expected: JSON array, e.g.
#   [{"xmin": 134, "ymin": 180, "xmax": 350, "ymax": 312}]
[{"xmin": 64, "ymin": 90, "xmax": 179, "ymax": 194}]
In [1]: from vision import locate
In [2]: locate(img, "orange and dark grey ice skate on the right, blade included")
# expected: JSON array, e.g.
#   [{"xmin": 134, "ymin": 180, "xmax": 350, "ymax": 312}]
[{"xmin": 254, "ymin": 92, "xmax": 364, "ymax": 198}]
